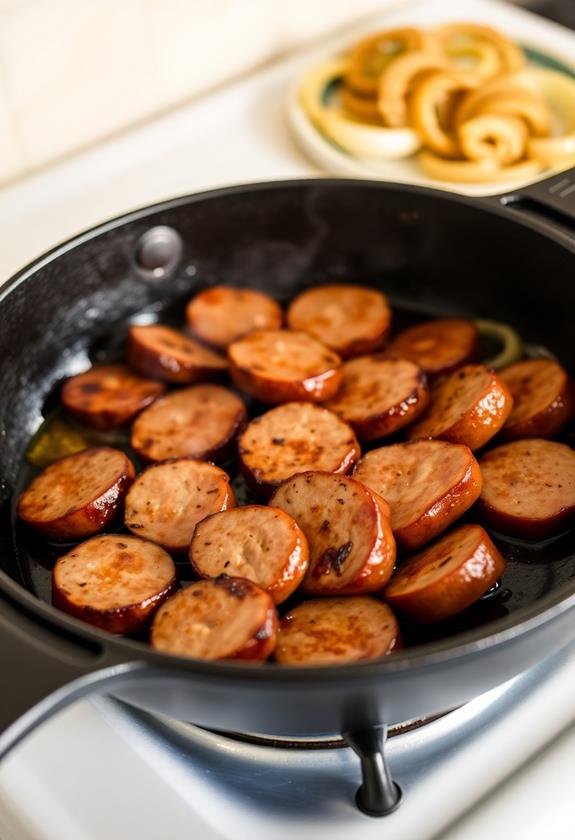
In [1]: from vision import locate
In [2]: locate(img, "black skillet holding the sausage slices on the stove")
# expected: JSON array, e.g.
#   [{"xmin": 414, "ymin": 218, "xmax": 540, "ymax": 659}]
[{"xmin": 0, "ymin": 170, "xmax": 575, "ymax": 813}]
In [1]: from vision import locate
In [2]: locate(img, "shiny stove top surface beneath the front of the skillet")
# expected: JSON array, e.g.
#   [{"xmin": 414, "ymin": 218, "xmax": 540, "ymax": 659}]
[{"xmin": 0, "ymin": 644, "xmax": 575, "ymax": 840}]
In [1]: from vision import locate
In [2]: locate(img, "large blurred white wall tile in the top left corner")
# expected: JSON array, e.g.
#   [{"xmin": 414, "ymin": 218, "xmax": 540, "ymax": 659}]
[{"xmin": 0, "ymin": 0, "xmax": 159, "ymax": 166}]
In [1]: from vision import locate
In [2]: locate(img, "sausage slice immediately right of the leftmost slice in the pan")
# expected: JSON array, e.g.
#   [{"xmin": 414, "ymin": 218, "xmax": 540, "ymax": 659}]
[{"xmin": 124, "ymin": 458, "xmax": 235, "ymax": 553}]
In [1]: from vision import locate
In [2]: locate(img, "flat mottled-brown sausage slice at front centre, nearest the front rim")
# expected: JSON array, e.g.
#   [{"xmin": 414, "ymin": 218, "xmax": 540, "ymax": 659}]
[{"xmin": 274, "ymin": 596, "xmax": 401, "ymax": 665}]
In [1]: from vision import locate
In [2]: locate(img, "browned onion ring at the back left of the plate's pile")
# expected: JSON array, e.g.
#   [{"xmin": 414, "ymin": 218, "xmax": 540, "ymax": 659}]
[{"xmin": 345, "ymin": 27, "xmax": 434, "ymax": 97}]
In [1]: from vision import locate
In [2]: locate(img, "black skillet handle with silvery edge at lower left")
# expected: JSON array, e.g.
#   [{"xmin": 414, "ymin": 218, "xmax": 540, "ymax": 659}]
[{"xmin": 0, "ymin": 599, "xmax": 139, "ymax": 760}]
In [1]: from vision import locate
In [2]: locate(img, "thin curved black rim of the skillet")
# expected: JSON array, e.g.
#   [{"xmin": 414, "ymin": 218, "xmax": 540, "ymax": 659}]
[{"xmin": 0, "ymin": 177, "xmax": 575, "ymax": 686}]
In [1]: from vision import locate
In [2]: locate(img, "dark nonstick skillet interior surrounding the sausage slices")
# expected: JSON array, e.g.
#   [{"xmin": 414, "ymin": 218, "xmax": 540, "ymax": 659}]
[{"xmin": 0, "ymin": 182, "xmax": 575, "ymax": 667}]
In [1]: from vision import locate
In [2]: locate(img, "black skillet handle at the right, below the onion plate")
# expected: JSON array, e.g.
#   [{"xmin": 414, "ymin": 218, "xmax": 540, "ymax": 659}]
[{"xmin": 490, "ymin": 167, "xmax": 575, "ymax": 239}]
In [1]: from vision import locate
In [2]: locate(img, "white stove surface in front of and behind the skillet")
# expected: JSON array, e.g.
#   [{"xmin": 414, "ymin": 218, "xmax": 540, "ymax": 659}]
[{"xmin": 0, "ymin": 0, "xmax": 575, "ymax": 840}]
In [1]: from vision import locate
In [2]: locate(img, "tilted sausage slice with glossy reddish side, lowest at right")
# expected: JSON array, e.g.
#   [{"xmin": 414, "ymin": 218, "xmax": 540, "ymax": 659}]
[{"xmin": 383, "ymin": 525, "xmax": 505, "ymax": 624}]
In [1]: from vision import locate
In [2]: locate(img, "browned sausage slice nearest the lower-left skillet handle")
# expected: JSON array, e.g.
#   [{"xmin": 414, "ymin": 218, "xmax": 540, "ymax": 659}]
[{"xmin": 52, "ymin": 534, "xmax": 177, "ymax": 634}]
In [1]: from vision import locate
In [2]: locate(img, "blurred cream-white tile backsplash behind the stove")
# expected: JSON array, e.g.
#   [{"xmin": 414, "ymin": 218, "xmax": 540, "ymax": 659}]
[{"xmin": 0, "ymin": 0, "xmax": 392, "ymax": 185}]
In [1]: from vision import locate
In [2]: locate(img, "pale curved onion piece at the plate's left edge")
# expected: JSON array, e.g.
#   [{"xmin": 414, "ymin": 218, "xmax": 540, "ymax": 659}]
[{"xmin": 299, "ymin": 58, "xmax": 421, "ymax": 160}]
